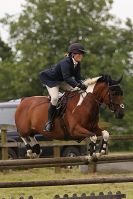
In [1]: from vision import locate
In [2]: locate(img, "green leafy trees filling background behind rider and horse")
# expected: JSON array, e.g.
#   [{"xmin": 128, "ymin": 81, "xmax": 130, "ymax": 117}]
[{"xmin": 0, "ymin": 0, "xmax": 133, "ymax": 143}]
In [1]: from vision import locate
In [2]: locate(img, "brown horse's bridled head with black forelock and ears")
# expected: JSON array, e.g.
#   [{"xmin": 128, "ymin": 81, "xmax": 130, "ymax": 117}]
[{"xmin": 94, "ymin": 75, "xmax": 124, "ymax": 119}]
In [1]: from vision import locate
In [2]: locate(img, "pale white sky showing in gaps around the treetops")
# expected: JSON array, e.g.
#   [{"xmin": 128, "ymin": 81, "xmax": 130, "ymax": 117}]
[{"xmin": 0, "ymin": 0, "xmax": 133, "ymax": 41}]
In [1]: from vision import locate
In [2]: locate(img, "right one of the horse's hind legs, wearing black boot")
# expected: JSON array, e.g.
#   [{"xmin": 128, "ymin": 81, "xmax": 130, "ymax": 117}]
[{"xmin": 29, "ymin": 136, "xmax": 41, "ymax": 158}]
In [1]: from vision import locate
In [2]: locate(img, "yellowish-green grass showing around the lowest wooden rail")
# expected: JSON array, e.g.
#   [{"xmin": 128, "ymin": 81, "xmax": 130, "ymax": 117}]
[{"xmin": 0, "ymin": 166, "xmax": 133, "ymax": 199}]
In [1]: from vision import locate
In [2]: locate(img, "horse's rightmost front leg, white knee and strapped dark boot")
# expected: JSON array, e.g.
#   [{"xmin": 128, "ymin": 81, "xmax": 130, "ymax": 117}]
[{"xmin": 99, "ymin": 130, "xmax": 109, "ymax": 155}]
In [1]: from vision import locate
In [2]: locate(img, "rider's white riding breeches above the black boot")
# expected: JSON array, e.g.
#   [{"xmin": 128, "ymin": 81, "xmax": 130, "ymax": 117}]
[{"xmin": 46, "ymin": 82, "xmax": 72, "ymax": 106}]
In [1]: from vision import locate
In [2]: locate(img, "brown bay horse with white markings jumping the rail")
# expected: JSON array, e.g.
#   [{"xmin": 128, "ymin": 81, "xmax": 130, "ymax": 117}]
[{"xmin": 15, "ymin": 75, "xmax": 124, "ymax": 158}]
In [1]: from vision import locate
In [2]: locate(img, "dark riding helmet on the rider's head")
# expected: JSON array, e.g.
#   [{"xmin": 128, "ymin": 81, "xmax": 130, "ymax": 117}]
[{"xmin": 68, "ymin": 43, "xmax": 86, "ymax": 54}]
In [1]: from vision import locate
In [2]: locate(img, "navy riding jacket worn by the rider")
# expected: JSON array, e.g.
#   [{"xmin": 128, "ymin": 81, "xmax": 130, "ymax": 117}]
[{"xmin": 39, "ymin": 57, "xmax": 81, "ymax": 87}]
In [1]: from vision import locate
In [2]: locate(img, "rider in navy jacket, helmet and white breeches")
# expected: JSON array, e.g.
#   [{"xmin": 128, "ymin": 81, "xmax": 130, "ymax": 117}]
[{"xmin": 39, "ymin": 43, "xmax": 86, "ymax": 132}]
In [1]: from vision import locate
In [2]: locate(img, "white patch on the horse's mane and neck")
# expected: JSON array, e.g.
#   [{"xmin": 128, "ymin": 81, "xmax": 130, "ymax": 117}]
[{"xmin": 77, "ymin": 76, "xmax": 100, "ymax": 106}]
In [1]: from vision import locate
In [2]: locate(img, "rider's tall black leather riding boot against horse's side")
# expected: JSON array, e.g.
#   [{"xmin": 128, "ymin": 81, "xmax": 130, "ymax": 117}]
[{"xmin": 44, "ymin": 104, "xmax": 56, "ymax": 132}]
